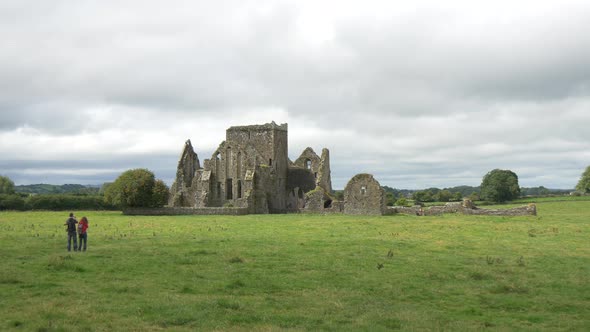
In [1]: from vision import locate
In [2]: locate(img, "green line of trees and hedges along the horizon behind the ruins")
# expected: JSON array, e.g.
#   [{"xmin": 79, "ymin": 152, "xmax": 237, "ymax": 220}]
[{"xmin": 0, "ymin": 166, "xmax": 590, "ymax": 210}]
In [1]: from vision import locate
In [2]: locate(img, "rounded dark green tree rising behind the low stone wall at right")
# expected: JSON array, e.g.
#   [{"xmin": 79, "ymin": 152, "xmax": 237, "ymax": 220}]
[{"xmin": 480, "ymin": 169, "xmax": 520, "ymax": 202}]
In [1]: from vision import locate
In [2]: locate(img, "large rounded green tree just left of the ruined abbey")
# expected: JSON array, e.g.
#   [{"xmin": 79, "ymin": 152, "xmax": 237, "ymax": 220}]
[{"xmin": 104, "ymin": 168, "xmax": 168, "ymax": 208}]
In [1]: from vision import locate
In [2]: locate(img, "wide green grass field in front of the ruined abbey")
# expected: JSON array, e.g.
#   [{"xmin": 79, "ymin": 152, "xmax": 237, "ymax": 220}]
[{"xmin": 0, "ymin": 200, "xmax": 590, "ymax": 331}]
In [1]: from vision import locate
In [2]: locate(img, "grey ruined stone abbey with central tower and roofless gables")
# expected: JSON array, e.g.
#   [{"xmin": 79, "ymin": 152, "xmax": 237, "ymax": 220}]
[{"xmin": 169, "ymin": 122, "xmax": 385, "ymax": 214}]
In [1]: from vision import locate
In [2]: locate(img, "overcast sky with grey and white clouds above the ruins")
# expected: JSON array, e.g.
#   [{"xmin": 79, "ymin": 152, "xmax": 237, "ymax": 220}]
[{"xmin": 0, "ymin": 0, "xmax": 590, "ymax": 189}]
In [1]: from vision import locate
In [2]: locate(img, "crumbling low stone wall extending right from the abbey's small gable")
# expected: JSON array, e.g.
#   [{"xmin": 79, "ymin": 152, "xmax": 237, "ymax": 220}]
[{"xmin": 387, "ymin": 201, "xmax": 537, "ymax": 216}]
